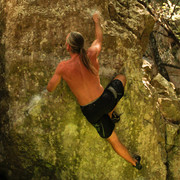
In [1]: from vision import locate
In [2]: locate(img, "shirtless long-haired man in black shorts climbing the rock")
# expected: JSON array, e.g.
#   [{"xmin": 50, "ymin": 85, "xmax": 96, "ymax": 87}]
[{"xmin": 47, "ymin": 13, "xmax": 142, "ymax": 170}]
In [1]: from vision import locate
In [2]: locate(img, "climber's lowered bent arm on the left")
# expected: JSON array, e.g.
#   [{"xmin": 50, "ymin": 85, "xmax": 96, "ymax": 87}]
[{"xmin": 47, "ymin": 63, "xmax": 62, "ymax": 92}]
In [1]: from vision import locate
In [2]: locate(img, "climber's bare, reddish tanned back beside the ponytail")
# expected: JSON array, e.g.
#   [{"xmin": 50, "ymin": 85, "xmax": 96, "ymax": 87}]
[{"xmin": 58, "ymin": 46, "xmax": 104, "ymax": 106}]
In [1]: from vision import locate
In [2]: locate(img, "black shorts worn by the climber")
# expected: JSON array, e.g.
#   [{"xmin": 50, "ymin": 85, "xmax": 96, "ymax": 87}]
[{"xmin": 81, "ymin": 79, "xmax": 124, "ymax": 138}]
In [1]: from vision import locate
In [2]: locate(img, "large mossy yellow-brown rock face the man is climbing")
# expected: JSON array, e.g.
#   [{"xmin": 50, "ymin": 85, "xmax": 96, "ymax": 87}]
[{"xmin": 0, "ymin": 0, "xmax": 180, "ymax": 180}]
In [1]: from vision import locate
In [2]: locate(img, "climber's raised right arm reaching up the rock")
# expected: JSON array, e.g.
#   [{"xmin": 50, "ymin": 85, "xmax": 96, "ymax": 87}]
[{"xmin": 90, "ymin": 12, "xmax": 103, "ymax": 56}]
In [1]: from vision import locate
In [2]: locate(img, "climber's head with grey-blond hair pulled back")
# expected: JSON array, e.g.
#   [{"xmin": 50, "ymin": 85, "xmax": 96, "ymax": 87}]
[{"xmin": 66, "ymin": 32, "xmax": 84, "ymax": 54}]
